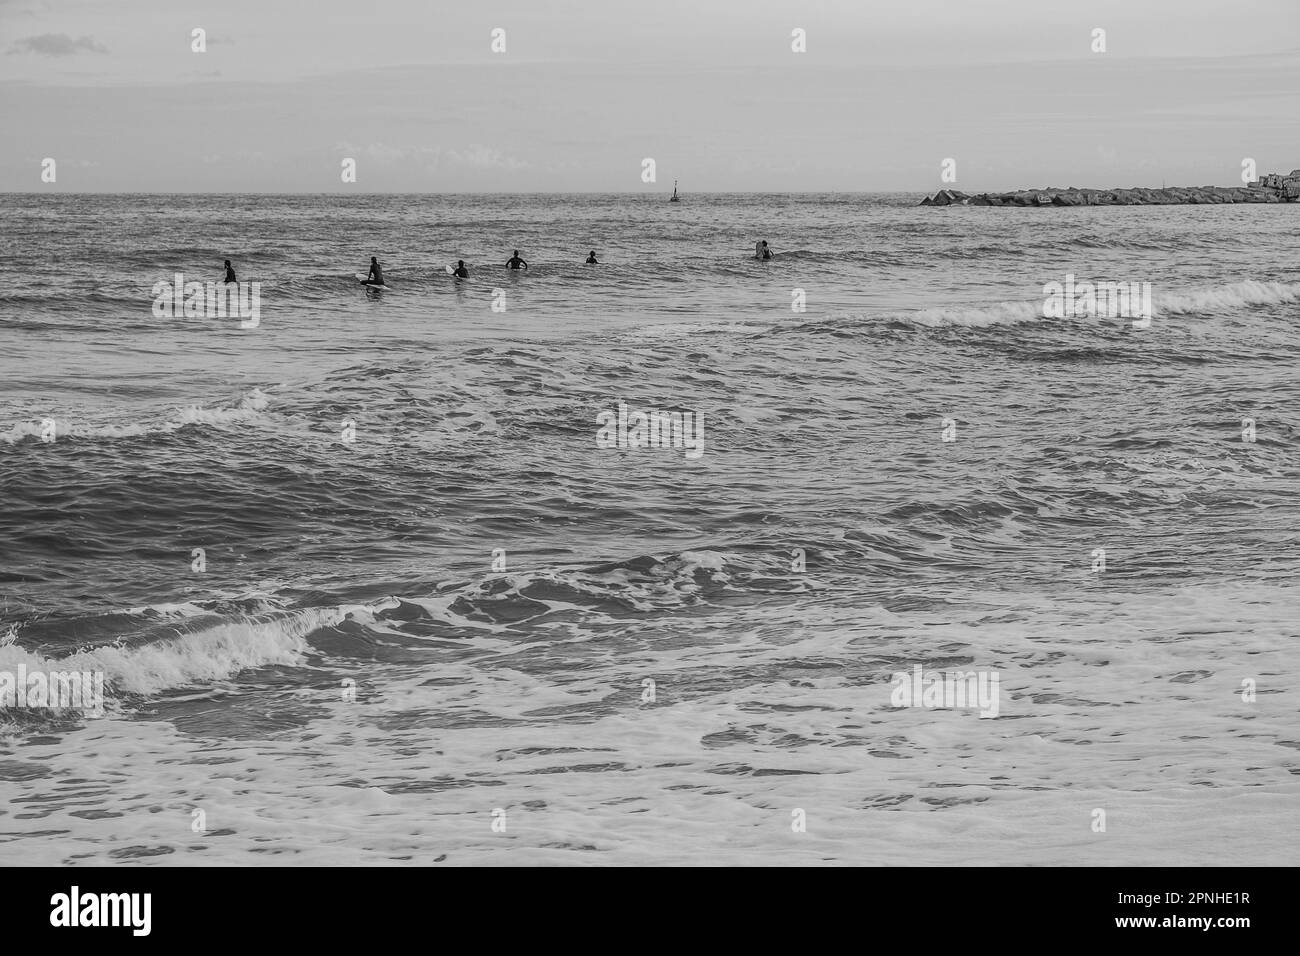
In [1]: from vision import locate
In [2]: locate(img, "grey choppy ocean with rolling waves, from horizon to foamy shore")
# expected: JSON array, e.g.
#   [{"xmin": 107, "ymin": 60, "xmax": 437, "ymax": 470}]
[{"xmin": 0, "ymin": 193, "xmax": 1300, "ymax": 865}]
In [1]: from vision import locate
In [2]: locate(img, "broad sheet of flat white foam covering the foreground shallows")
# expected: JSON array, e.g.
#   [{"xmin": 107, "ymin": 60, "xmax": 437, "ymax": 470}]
[{"xmin": 7, "ymin": 574, "xmax": 1300, "ymax": 865}]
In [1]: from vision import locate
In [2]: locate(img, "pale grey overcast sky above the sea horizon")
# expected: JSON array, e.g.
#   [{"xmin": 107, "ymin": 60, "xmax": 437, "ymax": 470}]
[{"xmin": 0, "ymin": 0, "xmax": 1300, "ymax": 193}]
